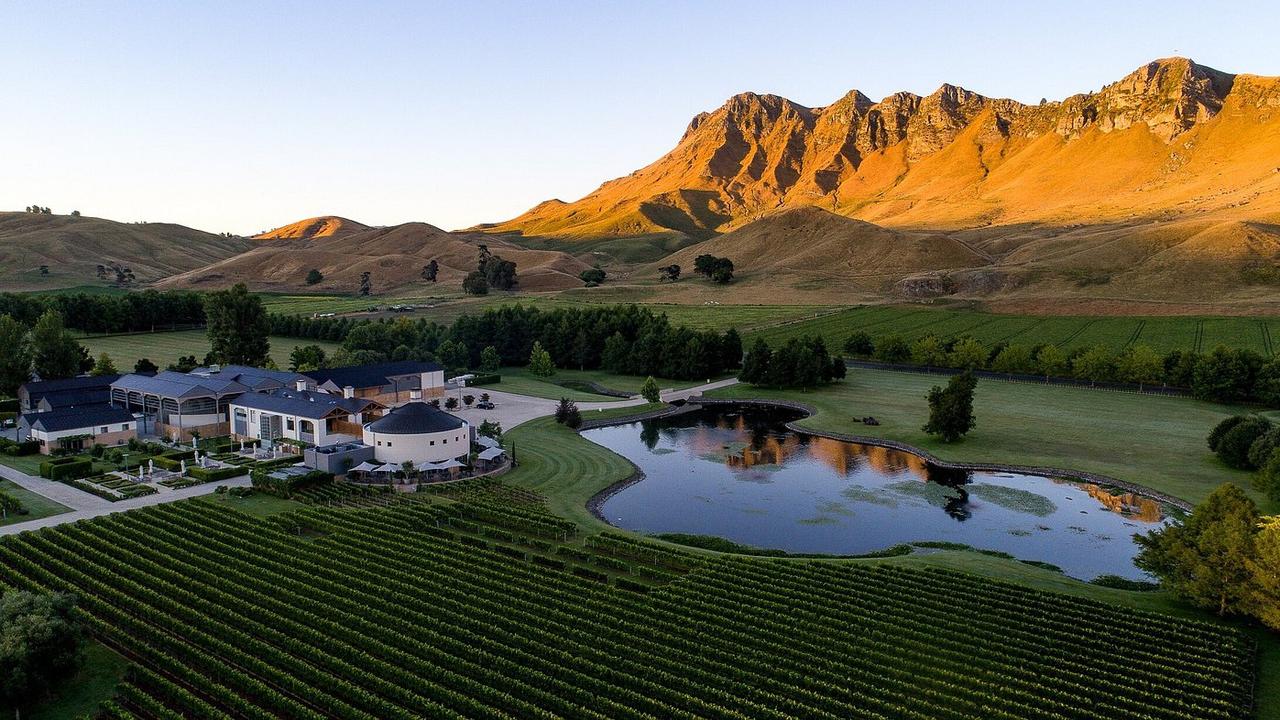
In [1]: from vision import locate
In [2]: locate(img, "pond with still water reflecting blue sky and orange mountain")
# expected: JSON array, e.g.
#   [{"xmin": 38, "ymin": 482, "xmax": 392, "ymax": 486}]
[{"xmin": 582, "ymin": 405, "xmax": 1165, "ymax": 580}]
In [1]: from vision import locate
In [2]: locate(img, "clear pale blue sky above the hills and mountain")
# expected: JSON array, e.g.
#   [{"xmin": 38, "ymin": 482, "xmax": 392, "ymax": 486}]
[{"xmin": 0, "ymin": 0, "xmax": 1280, "ymax": 234}]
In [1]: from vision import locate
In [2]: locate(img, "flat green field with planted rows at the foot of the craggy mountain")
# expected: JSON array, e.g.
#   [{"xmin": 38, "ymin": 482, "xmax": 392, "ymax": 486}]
[{"xmin": 748, "ymin": 306, "xmax": 1280, "ymax": 356}]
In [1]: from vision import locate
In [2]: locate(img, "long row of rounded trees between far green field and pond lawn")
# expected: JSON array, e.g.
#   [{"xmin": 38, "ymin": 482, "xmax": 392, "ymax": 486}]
[{"xmin": 845, "ymin": 332, "xmax": 1280, "ymax": 406}]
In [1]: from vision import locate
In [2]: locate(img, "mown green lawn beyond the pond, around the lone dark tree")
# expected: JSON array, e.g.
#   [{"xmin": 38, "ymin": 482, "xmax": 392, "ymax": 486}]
[{"xmin": 709, "ymin": 369, "xmax": 1280, "ymax": 510}]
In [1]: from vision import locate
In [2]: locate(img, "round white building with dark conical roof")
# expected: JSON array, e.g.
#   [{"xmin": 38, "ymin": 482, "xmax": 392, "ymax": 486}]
[{"xmin": 364, "ymin": 402, "xmax": 471, "ymax": 468}]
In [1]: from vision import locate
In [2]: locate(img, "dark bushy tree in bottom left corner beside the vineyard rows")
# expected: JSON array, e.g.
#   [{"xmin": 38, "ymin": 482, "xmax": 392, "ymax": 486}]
[{"xmin": 0, "ymin": 591, "xmax": 86, "ymax": 717}]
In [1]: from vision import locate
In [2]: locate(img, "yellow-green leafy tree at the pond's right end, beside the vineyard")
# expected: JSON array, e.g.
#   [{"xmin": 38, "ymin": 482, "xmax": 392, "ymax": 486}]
[{"xmin": 1133, "ymin": 483, "xmax": 1260, "ymax": 615}]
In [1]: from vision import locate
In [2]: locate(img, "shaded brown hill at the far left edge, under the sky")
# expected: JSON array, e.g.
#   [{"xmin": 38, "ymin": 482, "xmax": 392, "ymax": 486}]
[{"xmin": 0, "ymin": 213, "xmax": 251, "ymax": 290}]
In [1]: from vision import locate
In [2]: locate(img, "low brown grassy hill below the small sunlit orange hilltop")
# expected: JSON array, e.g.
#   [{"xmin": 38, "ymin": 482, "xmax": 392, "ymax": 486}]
[{"xmin": 159, "ymin": 220, "xmax": 588, "ymax": 295}]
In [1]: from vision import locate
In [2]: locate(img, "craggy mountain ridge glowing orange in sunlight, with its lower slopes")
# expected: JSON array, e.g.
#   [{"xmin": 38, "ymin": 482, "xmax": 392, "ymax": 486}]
[{"xmin": 475, "ymin": 58, "xmax": 1280, "ymax": 309}]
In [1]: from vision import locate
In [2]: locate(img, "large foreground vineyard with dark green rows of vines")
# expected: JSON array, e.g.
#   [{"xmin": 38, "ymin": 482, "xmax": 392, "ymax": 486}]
[{"xmin": 0, "ymin": 484, "xmax": 1254, "ymax": 720}]
